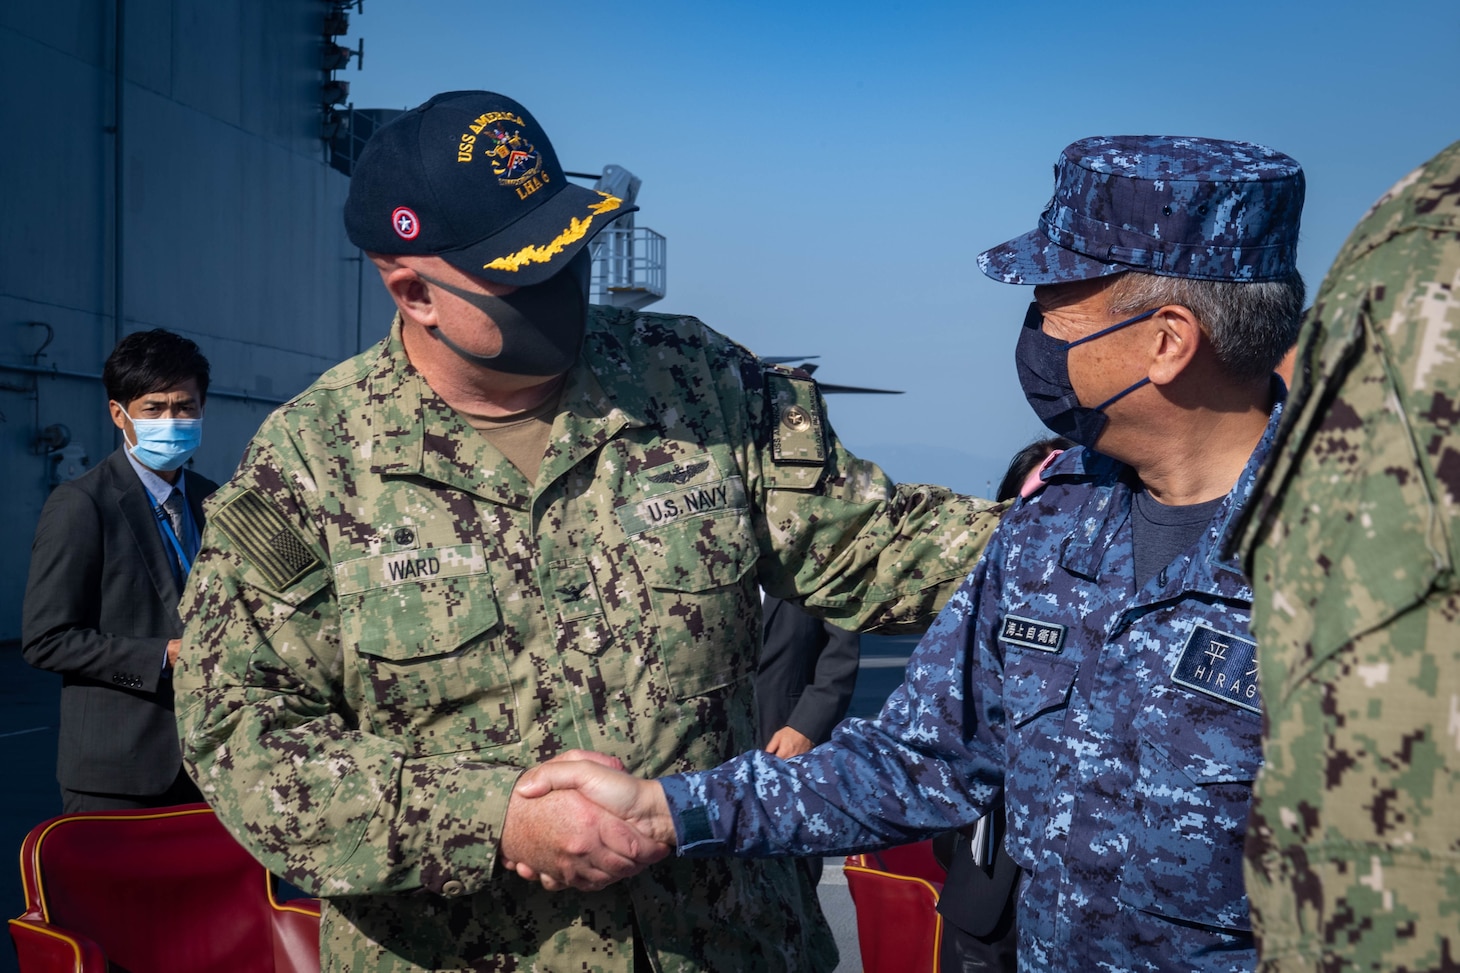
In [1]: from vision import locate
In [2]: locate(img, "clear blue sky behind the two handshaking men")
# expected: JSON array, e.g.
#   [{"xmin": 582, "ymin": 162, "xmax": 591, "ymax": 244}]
[{"xmin": 340, "ymin": 0, "xmax": 1460, "ymax": 494}]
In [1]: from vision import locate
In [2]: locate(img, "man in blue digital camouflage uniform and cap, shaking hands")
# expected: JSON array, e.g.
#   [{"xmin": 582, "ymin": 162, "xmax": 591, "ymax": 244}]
[{"xmin": 518, "ymin": 137, "xmax": 1304, "ymax": 972}]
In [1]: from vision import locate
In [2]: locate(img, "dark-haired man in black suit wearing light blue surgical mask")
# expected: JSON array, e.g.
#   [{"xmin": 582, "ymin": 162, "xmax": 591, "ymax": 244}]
[{"xmin": 22, "ymin": 329, "xmax": 218, "ymax": 812}]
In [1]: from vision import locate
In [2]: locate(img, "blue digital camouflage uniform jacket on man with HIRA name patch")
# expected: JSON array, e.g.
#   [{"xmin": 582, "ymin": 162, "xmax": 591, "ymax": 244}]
[{"xmin": 663, "ymin": 405, "xmax": 1282, "ymax": 972}]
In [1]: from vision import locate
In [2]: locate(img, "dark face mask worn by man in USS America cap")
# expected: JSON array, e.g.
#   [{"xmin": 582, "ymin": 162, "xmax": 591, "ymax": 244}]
[{"xmin": 416, "ymin": 247, "xmax": 593, "ymax": 377}]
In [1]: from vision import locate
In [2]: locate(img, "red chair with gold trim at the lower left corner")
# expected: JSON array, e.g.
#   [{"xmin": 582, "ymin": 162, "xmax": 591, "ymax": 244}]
[{"xmin": 10, "ymin": 804, "xmax": 320, "ymax": 973}]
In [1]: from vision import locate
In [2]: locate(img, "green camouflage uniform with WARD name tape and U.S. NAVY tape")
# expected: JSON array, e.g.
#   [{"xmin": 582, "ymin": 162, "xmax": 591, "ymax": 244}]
[{"xmin": 175, "ymin": 308, "xmax": 997, "ymax": 973}]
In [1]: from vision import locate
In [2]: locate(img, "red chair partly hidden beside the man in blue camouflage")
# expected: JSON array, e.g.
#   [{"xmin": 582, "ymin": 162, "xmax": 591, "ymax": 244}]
[{"xmin": 842, "ymin": 842, "xmax": 946, "ymax": 973}]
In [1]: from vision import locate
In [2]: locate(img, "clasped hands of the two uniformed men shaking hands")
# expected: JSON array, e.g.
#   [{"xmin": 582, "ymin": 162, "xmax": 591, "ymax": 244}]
[{"xmin": 501, "ymin": 749, "xmax": 675, "ymax": 891}]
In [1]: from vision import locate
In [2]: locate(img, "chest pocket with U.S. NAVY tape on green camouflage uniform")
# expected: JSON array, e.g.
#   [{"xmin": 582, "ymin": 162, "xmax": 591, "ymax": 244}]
[{"xmin": 619, "ymin": 476, "xmax": 759, "ymax": 700}]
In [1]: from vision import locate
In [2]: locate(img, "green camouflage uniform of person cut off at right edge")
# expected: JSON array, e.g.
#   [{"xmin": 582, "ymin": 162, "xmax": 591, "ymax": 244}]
[{"xmin": 1242, "ymin": 143, "xmax": 1460, "ymax": 973}]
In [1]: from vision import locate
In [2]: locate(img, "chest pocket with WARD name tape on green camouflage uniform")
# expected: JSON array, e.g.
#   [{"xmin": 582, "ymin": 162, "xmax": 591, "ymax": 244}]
[{"xmin": 336, "ymin": 545, "xmax": 518, "ymax": 757}]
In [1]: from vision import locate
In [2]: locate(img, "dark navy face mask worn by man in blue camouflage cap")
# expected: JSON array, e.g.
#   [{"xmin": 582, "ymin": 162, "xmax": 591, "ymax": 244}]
[{"xmin": 1013, "ymin": 304, "xmax": 1161, "ymax": 449}]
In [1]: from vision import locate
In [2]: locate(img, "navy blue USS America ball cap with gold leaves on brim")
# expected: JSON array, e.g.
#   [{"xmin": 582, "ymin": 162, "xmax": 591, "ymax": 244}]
[{"xmin": 345, "ymin": 91, "xmax": 638, "ymax": 286}]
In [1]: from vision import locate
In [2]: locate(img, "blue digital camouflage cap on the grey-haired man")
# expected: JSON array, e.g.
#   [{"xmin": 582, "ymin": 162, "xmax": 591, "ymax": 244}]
[{"xmin": 978, "ymin": 136, "xmax": 1304, "ymax": 283}]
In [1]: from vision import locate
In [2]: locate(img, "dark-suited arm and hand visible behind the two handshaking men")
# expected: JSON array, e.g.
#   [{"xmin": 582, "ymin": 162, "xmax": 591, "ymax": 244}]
[{"xmin": 755, "ymin": 595, "xmax": 861, "ymax": 758}]
